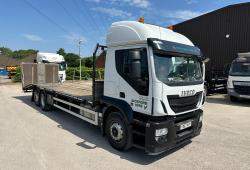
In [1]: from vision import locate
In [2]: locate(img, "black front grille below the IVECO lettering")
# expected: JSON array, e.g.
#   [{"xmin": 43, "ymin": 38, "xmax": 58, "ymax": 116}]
[{"xmin": 167, "ymin": 92, "xmax": 202, "ymax": 113}]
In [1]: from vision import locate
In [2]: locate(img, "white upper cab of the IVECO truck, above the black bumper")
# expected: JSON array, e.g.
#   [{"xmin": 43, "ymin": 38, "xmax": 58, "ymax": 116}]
[{"xmin": 104, "ymin": 21, "xmax": 204, "ymax": 116}]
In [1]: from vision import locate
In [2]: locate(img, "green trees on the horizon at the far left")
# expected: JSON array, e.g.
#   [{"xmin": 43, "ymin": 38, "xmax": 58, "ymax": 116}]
[{"xmin": 0, "ymin": 47, "xmax": 38, "ymax": 59}]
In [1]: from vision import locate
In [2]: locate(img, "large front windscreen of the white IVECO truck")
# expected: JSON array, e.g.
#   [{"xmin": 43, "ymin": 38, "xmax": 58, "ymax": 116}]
[{"xmin": 154, "ymin": 54, "xmax": 203, "ymax": 85}]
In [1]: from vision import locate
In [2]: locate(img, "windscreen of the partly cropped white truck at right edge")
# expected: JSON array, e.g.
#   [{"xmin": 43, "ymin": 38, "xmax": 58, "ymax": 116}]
[{"xmin": 229, "ymin": 57, "xmax": 250, "ymax": 76}]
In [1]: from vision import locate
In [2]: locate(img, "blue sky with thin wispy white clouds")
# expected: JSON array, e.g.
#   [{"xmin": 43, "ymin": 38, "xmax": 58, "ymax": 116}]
[{"xmin": 0, "ymin": 0, "xmax": 247, "ymax": 57}]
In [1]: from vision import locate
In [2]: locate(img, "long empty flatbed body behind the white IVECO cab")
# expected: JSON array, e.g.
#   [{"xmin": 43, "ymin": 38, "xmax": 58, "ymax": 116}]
[{"xmin": 32, "ymin": 80, "xmax": 103, "ymax": 126}]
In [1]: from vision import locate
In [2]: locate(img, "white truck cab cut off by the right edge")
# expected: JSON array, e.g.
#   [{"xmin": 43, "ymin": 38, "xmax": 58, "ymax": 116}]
[{"xmin": 227, "ymin": 52, "xmax": 250, "ymax": 101}]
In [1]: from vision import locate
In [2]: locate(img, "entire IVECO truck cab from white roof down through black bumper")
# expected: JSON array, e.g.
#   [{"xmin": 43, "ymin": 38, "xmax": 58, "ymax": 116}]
[{"xmin": 104, "ymin": 21, "xmax": 205, "ymax": 153}]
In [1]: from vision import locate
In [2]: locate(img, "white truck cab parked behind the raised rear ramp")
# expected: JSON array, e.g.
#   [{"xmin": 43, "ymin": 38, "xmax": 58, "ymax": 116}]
[{"xmin": 36, "ymin": 52, "xmax": 67, "ymax": 82}]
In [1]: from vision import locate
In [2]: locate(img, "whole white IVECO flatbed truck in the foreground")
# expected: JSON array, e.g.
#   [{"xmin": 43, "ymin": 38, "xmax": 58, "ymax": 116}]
[{"xmin": 25, "ymin": 21, "xmax": 204, "ymax": 154}]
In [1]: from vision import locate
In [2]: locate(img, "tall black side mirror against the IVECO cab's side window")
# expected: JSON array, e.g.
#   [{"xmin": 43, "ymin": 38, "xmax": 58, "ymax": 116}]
[{"xmin": 129, "ymin": 50, "xmax": 141, "ymax": 79}]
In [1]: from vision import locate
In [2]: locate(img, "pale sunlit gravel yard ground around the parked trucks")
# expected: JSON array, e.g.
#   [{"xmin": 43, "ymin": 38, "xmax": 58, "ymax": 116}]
[{"xmin": 0, "ymin": 84, "xmax": 250, "ymax": 170}]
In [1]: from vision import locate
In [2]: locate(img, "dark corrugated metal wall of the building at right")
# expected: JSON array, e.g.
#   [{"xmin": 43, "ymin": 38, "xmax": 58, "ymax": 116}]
[{"xmin": 173, "ymin": 3, "xmax": 250, "ymax": 77}]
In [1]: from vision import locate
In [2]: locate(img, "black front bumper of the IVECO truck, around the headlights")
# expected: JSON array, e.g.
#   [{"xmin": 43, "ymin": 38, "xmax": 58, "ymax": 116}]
[{"xmin": 145, "ymin": 110, "xmax": 203, "ymax": 155}]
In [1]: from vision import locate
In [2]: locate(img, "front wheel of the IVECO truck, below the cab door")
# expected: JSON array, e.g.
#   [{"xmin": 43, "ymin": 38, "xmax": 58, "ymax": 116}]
[{"xmin": 105, "ymin": 112, "xmax": 132, "ymax": 151}]
